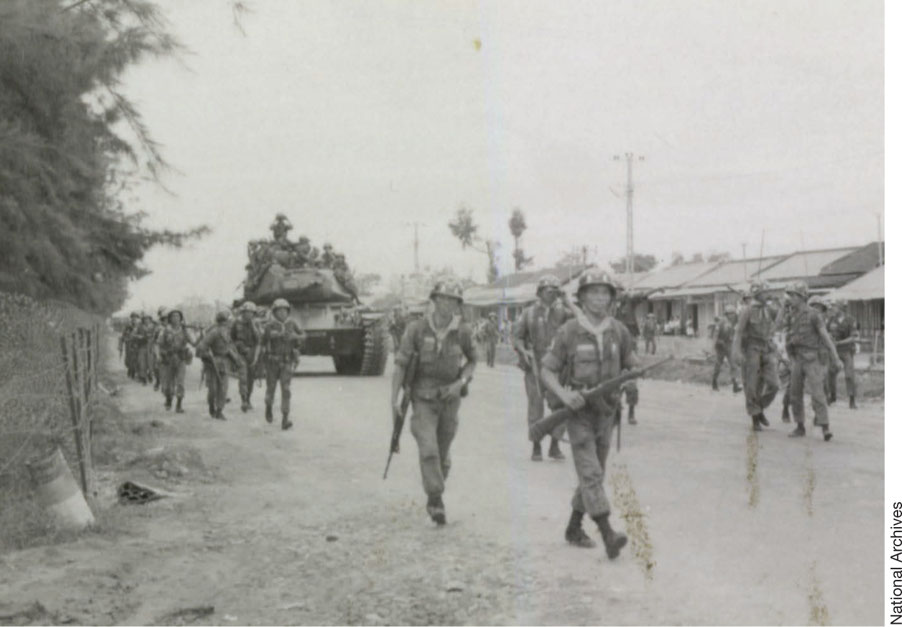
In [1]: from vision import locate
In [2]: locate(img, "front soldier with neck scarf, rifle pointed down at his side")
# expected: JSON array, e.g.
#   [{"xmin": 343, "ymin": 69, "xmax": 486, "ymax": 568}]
[{"xmin": 391, "ymin": 281, "xmax": 476, "ymax": 525}]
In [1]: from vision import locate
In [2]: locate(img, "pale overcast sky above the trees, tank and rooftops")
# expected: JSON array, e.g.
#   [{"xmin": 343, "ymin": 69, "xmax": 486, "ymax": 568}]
[{"xmin": 116, "ymin": 0, "xmax": 884, "ymax": 309}]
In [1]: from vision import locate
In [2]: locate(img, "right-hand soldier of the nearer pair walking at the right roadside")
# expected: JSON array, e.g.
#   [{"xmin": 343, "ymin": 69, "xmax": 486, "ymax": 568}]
[{"xmin": 786, "ymin": 281, "xmax": 839, "ymax": 442}]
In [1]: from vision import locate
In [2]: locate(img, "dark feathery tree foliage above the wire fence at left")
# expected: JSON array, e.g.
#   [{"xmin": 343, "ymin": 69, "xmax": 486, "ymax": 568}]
[{"xmin": 0, "ymin": 0, "xmax": 207, "ymax": 313}]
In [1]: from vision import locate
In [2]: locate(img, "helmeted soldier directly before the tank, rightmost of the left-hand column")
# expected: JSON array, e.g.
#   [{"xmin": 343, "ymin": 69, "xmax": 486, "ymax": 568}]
[{"xmin": 261, "ymin": 298, "xmax": 304, "ymax": 431}]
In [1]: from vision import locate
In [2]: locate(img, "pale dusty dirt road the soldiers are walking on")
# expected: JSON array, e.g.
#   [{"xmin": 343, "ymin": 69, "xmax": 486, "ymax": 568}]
[{"xmin": 0, "ymin": 361, "xmax": 884, "ymax": 624}]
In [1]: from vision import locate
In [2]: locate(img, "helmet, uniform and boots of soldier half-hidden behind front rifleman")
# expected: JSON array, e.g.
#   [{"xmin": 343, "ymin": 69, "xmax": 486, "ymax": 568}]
[{"xmin": 513, "ymin": 277, "xmax": 569, "ymax": 461}]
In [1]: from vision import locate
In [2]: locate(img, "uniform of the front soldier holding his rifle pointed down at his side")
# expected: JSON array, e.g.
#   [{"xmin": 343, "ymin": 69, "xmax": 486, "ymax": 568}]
[{"xmin": 395, "ymin": 308, "xmax": 476, "ymax": 516}]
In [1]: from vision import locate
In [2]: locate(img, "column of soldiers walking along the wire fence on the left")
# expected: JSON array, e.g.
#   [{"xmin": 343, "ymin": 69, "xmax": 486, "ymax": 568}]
[{"xmin": 119, "ymin": 298, "xmax": 304, "ymax": 430}]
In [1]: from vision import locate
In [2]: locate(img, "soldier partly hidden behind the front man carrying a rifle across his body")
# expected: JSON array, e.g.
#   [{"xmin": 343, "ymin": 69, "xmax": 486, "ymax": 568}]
[{"xmin": 513, "ymin": 275, "xmax": 569, "ymax": 462}]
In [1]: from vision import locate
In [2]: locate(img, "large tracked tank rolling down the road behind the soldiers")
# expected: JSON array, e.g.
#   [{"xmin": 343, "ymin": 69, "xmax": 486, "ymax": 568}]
[{"xmin": 244, "ymin": 221, "xmax": 389, "ymax": 376}]
